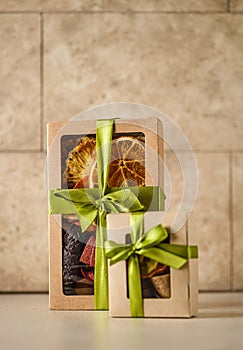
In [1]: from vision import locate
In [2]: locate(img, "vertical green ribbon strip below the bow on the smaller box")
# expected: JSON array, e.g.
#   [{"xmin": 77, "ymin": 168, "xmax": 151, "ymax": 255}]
[{"xmin": 128, "ymin": 254, "xmax": 143, "ymax": 317}]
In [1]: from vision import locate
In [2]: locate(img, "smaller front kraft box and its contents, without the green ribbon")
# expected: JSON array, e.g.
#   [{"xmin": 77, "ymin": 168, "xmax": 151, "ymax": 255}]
[{"xmin": 107, "ymin": 212, "xmax": 198, "ymax": 318}]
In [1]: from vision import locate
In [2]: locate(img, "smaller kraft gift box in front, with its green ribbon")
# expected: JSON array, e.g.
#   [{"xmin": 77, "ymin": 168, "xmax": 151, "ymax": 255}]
[{"xmin": 106, "ymin": 212, "xmax": 198, "ymax": 318}]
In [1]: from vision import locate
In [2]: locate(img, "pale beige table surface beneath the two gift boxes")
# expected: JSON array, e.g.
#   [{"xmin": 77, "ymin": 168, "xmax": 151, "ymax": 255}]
[{"xmin": 0, "ymin": 293, "xmax": 243, "ymax": 350}]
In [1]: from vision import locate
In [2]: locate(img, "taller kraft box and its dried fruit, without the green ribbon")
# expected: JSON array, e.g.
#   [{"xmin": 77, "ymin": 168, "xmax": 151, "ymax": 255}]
[{"xmin": 47, "ymin": 118, "xmax": 163, "ymax": 310}]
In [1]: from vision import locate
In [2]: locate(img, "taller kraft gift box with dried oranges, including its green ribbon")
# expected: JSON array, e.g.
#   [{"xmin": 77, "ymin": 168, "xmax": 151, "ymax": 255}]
[{"xmin": 47, "ymin": 118, "xmax": 164, "ymax": 310}]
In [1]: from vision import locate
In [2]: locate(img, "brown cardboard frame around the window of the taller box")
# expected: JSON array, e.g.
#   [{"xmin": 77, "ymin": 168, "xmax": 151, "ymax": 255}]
[{"xmin": 47, "ymin": 118, "xmax": 163, "ymax": 310}]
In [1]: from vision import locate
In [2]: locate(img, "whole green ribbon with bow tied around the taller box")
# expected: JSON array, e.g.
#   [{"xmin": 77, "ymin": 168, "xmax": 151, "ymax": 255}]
[{"xmin": 49, "ymin": 119, "xmax": 164, "ymax": 310}]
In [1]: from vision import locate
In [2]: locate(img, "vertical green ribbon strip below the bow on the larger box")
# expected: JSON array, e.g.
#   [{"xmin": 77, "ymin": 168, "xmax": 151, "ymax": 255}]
[{"xmin": 94, "ymin": 211, "xmax": 109, "ymax": 310}]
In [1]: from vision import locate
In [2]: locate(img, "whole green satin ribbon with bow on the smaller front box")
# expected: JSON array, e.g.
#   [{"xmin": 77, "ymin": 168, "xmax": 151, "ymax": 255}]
[{"xmin": 105, "ymin": 213, "xmax": 198, "ymax": 317}]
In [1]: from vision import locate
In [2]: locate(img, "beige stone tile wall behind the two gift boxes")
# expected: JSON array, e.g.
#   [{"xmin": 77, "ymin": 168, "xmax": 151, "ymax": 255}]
[{"xmin": 0, "ymin": 0, "xmax": 243, "ymax": 291}]
